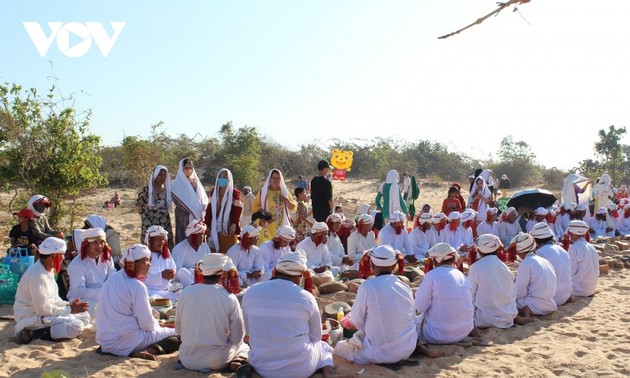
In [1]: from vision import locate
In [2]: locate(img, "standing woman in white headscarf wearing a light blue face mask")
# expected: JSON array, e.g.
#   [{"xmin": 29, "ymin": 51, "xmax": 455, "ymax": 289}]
[{"xmin": 204, "ymin": 168, "xmax": 243, "ymax": 253}]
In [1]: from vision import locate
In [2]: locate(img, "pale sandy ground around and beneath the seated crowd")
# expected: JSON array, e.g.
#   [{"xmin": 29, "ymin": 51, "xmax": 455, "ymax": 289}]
[{"xmin": 0, "ymin": 180, "xmax": 630, "ymax": 377}]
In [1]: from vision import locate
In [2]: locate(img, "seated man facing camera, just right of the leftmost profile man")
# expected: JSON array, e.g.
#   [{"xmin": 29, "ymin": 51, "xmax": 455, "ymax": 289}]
[{"xmin": 68, "ymin": 228, "xmax": 116, "ymax": 317}]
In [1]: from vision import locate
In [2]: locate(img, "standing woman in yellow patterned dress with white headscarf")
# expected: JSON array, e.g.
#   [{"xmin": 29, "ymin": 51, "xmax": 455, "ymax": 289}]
[{"xmin": 254, "ymin": 168, "xmax": 297, "ymax": 242}]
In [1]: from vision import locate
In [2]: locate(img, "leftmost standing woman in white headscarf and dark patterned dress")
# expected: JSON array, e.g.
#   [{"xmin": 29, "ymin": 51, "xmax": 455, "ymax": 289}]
[{"xmin": 136, "ymin": 165, "xmax": 174, "ymax": 249}]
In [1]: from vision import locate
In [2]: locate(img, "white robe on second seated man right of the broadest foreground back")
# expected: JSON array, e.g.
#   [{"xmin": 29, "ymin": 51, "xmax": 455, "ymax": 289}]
[{"xmin": 414, "ymin": 266, "xmax": 475, "ymax": 344}]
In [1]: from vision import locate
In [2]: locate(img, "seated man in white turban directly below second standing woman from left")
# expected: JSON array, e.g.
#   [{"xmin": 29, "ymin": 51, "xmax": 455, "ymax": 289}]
[{"xmin": 173, "ymin": 219, "xmax": 210, "ymax": 287}]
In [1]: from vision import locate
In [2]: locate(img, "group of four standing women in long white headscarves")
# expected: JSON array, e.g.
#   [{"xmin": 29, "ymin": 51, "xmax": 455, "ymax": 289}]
[{"xmin": 136, "ymin": 158, "xmax": 296, "ymax": 253}]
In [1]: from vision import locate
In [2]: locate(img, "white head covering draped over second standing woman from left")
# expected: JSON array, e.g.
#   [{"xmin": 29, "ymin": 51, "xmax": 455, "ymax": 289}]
[{"xmin": 171, "ymin": 159, "xmax": 208, "ymax": 221}]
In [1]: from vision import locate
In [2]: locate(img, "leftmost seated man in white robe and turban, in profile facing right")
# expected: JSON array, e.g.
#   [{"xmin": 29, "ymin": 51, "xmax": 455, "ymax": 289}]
[{"xmin": 13, "ymin": 237, "xmax": 90, "ymax": 344}]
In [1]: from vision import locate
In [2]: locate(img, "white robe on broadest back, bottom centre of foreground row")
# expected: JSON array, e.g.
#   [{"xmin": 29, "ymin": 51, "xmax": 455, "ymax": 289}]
[{"xmin": 243, "ymin": 279, "xmax": 333, "ymax": 378}]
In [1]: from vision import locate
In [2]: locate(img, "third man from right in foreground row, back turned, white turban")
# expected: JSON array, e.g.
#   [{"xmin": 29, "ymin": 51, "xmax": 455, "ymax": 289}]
[{"xmin": 512, "ymin": 232, "xmax": 558, "ymax": 324}]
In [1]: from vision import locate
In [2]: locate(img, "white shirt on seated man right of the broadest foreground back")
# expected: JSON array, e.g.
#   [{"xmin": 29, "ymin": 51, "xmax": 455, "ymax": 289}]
[{"xmin": 350, "ymin": 274, "xmax": 418, "ymax": 364}]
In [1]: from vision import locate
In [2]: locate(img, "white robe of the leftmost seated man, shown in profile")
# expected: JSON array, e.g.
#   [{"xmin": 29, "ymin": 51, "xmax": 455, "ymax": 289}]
[{"xmin": 13, "ymin": 257, "xmax": 90, "ymax": 339}]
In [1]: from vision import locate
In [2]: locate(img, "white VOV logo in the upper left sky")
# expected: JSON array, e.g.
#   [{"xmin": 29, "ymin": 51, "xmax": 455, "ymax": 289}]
[{"xmin": 22, "ymin": 22, "xmax": 126, "ymax": 58}]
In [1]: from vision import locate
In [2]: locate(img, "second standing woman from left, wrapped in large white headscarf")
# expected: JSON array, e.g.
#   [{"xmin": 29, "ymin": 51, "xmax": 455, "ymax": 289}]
[{"xmin": 171, "ymin": 158, "xmax": 208, "ymax": 244}]
